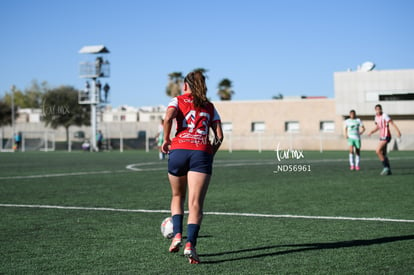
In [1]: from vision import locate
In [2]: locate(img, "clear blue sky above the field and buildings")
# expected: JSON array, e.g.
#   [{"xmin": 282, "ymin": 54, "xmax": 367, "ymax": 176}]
[{"xmin": 0, "ymin": 0, "xmax": 414, "ymax": 107}]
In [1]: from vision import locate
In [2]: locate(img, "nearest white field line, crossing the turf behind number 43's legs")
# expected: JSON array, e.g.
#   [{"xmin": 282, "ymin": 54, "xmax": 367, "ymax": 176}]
[{"xmin": 0, "ymin": 204, "xmax": 414, "ymax": 223}]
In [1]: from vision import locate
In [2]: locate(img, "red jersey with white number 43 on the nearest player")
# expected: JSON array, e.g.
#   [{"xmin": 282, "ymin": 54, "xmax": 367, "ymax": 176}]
[{"xmin": 168, "ymin": 93, "xmax": 220, "ymax": 154}]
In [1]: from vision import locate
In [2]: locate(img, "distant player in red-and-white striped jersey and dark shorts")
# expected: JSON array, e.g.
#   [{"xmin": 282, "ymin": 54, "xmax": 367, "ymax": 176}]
[{"xmin": 368, "ymin": 104, "xmax": 401, "ymax": 176}]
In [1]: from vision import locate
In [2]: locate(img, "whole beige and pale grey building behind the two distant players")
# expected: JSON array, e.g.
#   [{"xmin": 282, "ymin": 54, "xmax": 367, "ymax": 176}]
[{"xmin": 215, "ymin": 67, "xmax": 414, "ymax": 151}]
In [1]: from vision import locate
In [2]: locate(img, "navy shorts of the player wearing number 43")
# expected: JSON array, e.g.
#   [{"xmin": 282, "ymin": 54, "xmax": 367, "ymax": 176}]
[{"xmin": 168, "ymin": 149, "xmax": 213, "ymax": 177}]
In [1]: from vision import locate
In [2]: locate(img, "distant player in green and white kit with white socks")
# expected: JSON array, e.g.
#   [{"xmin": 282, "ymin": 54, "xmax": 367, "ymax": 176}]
[{"xmin": 345, "ymin": 110, "xmax": 365, "ymax": 171}]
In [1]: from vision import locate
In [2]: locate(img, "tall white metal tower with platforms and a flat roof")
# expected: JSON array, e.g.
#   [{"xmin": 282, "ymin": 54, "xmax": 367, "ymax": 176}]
[{"xmin": 78, "ymin": 45, "xmax": 110, "ymax": 151}]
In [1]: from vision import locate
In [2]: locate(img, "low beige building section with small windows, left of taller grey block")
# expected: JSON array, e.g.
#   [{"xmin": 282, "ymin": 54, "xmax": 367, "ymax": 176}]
[{"xmin": 214, "ymin": 98, "xmax": 345, "ymax": 151}]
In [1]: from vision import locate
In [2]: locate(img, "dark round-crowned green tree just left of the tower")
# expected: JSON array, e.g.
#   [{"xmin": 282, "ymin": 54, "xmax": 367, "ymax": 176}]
[{"xmin": 42, "ymin": 86, "xmax": 90, "ymax": 147}]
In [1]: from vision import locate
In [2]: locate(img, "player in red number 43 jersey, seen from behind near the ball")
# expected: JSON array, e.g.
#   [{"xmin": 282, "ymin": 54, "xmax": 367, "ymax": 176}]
[{"xmin": 162, "ymin": 71, "xmax": 223, "ymax": 264}]
